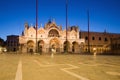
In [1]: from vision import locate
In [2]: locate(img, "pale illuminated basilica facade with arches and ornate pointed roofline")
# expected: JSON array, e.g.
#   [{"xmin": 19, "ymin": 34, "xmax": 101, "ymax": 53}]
[{"xmin": 19, "ymin": 21, "xmax": 85, "ymax": 53}]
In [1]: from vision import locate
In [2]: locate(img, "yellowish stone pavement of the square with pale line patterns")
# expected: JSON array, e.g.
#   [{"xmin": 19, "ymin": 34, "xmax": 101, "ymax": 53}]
[{"xmin": 0, "ymin": 55, "xmax": 120, "ymax": 80}]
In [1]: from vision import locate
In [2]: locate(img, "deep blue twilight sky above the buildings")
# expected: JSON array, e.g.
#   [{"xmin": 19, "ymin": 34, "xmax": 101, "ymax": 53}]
[{"xmin": 0, "ymin": 0, "xmax": 120, "ymax": 40}]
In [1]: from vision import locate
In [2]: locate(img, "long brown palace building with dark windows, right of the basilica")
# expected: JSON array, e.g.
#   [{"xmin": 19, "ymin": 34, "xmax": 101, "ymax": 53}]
[{"xmin": 79, "ymin": 31, "xmax": 120, "ymax": 54}]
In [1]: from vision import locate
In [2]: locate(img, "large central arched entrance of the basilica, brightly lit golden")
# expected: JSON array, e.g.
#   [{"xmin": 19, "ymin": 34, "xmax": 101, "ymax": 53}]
[{"xmin": 50, "ymin": 38, "xmax": 60, "ymax": 52}]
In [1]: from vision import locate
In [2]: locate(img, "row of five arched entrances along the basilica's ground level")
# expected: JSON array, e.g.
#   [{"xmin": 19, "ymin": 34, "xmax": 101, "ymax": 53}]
[{"xmin": 27, "ymin": 38, "xmax": 80, "ymax": 53}]
